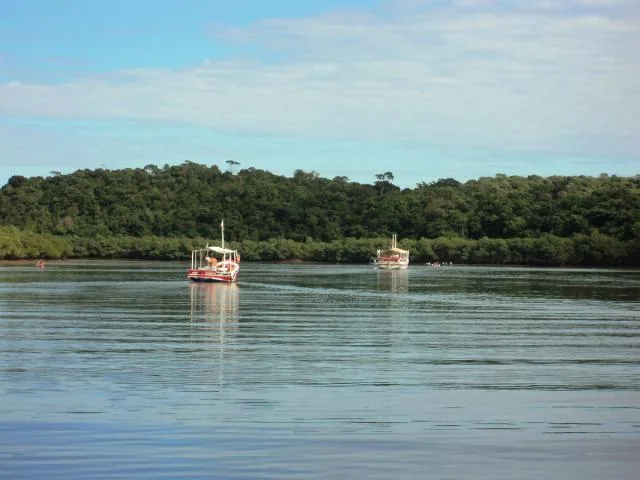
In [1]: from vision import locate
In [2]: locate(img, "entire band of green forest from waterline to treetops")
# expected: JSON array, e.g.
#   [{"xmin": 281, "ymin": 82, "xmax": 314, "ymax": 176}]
[{"xmin": 0, "ymin": 161, "xmax": 640, "ymax": 266}]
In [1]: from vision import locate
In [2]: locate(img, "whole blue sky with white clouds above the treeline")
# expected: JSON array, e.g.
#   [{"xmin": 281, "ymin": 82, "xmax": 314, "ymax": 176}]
[{"xmin": 0, "ymin": 0, "xmax": 640, "ymax": 188}]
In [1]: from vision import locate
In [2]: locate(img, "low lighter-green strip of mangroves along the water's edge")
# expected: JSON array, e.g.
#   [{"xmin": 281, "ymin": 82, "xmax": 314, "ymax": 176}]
[{"xmin": 0, "ymin": 227, "xmax": 640, "ymax": 267}]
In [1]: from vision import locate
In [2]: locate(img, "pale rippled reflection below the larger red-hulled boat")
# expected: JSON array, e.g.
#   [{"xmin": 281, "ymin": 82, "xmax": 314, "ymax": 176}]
[{"xmin": 189, "ymin": 283, "xmax": 240, "ymax": 342}]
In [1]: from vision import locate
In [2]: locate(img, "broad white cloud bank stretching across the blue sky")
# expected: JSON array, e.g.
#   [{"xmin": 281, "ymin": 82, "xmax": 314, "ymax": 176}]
[{"xmin": 0, "ymin": 0, "xmax": 640, "ymax": 155}]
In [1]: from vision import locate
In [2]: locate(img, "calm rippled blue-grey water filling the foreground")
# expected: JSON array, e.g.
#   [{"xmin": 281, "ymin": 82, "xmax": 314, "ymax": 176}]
[{"xmin": 0, "ymin": 262, "xmax": 640, "ymax": 479}]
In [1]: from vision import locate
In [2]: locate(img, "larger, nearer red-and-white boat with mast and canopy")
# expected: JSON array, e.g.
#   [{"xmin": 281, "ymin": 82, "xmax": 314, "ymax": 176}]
[{"xmin": 187, "ymin": 220, "xmax": 240, "ymax": 283}]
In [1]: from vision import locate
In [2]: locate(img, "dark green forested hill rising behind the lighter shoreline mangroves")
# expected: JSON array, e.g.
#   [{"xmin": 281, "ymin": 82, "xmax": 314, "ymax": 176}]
[{"xmin": 0, "ymin": 162, "xmax": 640, "ymax": 242}]
